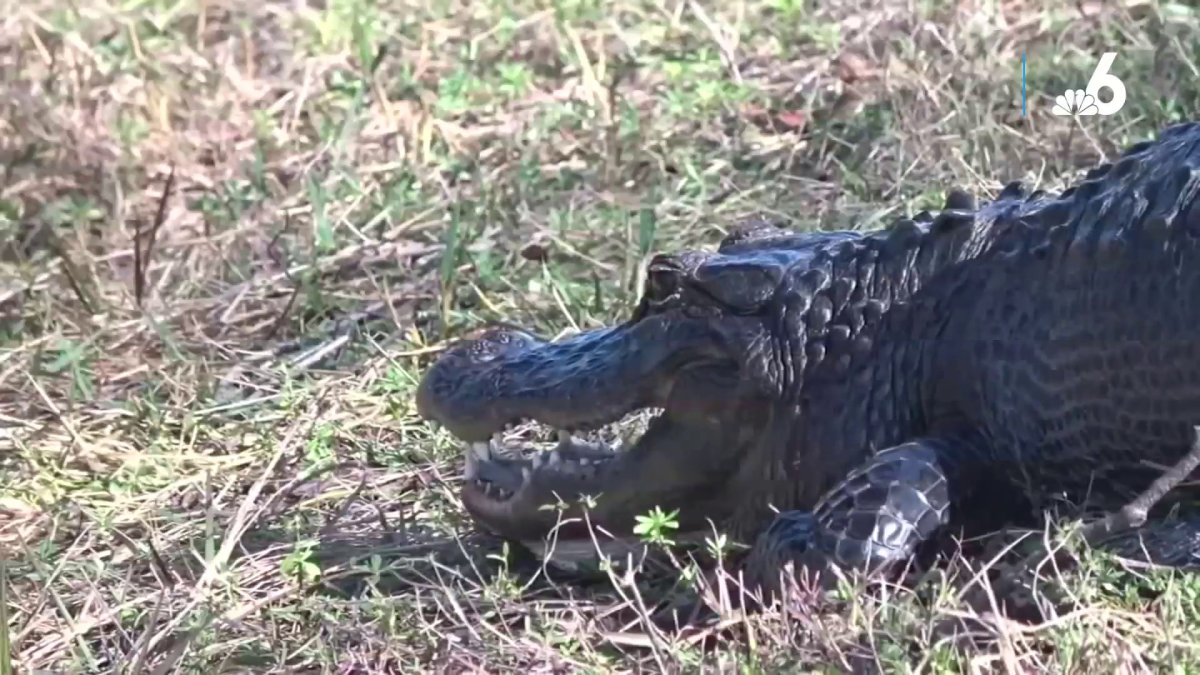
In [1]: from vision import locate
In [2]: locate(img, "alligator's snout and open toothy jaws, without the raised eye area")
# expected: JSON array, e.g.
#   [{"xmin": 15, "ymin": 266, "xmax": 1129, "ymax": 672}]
[{"xmin": 416, "ymin": 315, "xmax": 746, "ymax": 548}]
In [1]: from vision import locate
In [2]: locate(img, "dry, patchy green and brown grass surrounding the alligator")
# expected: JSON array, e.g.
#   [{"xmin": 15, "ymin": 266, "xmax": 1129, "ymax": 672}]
[{"xmin": 7, "ymin": 0, "xmax": 1200, "ymax": 673}]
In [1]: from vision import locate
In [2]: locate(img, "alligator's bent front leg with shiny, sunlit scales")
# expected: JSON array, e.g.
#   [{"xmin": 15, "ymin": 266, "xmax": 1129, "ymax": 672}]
[{"xmin": 745, "ymin": 438, "xmax": 973, "ymax": 593}]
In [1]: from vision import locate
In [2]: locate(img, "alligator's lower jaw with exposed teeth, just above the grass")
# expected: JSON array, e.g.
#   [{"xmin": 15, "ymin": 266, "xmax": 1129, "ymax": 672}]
[{"xmin": 451, "ymin": 391, "xmax": 742, "ymax": 554}]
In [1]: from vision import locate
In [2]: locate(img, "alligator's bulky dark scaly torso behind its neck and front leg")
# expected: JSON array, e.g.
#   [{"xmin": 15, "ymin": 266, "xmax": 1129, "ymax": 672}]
[{"xmin": 926, "ymin": 124, "xmax": 1200, "ymax": 507}]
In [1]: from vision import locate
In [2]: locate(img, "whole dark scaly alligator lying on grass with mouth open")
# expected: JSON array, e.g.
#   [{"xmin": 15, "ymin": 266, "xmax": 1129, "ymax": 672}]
[{"xmin": 416, "ymin": 123, "xmax": 1200, "ymax": 593}]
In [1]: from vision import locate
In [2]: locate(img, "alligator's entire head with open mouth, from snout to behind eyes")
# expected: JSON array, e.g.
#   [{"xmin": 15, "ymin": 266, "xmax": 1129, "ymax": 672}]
[{"xmin": 416, "ymin": 226, "xmax": 873, "ymax": 561}]
